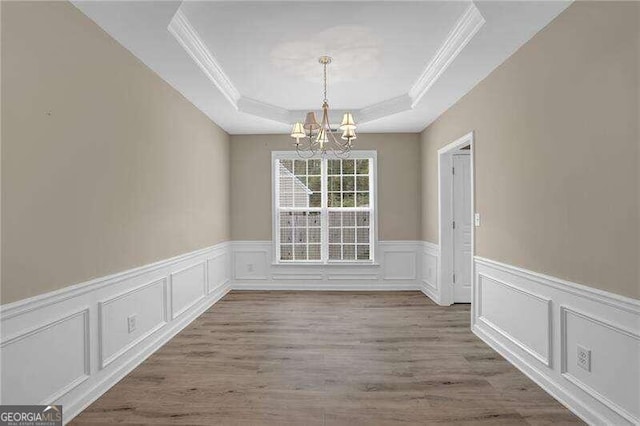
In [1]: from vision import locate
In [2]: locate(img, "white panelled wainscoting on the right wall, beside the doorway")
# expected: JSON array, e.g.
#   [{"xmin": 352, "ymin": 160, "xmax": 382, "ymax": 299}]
[{"xmin": 472, "ymin": 257, "xmax": 640, "ymax": 425}]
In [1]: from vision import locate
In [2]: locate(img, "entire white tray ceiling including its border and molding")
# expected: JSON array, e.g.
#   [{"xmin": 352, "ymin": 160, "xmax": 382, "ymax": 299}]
[{"xmin": 74, "ymin": 0, "xmax": 569, "ymax": 134}]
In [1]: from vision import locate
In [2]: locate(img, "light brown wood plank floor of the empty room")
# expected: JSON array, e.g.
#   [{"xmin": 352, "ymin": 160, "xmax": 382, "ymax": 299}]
[{"xmin": 72, "ymin": 291, "xmax": 579, "ymax": 425}]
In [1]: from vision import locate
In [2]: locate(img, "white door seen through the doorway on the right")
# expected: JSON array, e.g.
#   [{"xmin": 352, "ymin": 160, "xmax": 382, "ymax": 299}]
[{"xmin": 453, "ymin": 153, "xmax": 473, "ymax": 303}]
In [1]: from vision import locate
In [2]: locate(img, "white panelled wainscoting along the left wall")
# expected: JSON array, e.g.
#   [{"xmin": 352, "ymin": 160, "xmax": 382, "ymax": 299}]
[{"xmin": 0, "ymin": 242, "xmax": 231, "ymax": 422}]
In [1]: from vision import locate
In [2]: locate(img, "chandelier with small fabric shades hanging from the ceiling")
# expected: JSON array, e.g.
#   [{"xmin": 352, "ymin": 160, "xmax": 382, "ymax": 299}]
[{"xmin": 291, "ymin": 56, "xmax": 356, "ymax": 158}]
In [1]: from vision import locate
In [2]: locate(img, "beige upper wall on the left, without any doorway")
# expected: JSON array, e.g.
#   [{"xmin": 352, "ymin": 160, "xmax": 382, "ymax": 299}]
[{"xmin": 1, "ymin": 2, "xmax": 229, "ymax": 303}]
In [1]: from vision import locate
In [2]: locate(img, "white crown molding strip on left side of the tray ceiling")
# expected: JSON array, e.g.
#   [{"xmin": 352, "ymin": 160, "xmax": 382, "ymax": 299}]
[{"xmin": 168, "ymin": 9, "xmax": 241, "ymax": 110}]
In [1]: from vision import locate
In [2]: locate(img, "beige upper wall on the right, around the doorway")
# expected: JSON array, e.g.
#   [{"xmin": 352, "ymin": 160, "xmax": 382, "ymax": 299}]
[{"xmin": 422, "ymin": 2, "xmax": 640, "ymax": 298}]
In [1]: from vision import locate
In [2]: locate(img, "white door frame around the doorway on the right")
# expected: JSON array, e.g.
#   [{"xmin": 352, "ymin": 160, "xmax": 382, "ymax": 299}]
[{"xmin": 438, "ymin": 131, "xmax": 476, "ymax": 310}]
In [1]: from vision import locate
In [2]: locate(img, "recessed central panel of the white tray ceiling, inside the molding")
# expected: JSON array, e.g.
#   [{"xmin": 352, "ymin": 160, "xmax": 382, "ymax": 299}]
[{"xmin": 180, "ymin": 2, "xmax": 469, "ymax": 110}]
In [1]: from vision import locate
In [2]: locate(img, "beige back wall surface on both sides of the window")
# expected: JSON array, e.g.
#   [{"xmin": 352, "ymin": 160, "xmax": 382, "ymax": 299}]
[{"xmin": 231, "ymin": 133, "xmax": 420, "ymax": 241}]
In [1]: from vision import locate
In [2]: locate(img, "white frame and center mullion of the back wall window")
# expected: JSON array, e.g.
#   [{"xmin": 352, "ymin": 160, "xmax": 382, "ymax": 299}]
[{"xmin": 271, "ymin": 150, "xmax": 378, "ymax": 265}]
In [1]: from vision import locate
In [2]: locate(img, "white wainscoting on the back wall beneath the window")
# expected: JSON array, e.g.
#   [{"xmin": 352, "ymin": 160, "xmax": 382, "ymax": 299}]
[{"xmin": 231, "ymin": 241, "xmax": 422, "ymax": 290}]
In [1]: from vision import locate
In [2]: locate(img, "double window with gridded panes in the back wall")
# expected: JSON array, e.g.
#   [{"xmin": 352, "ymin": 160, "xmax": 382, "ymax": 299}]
[{"xmin": 273, "ymin": 151, "xmax": 376, "ymax": 263}]
